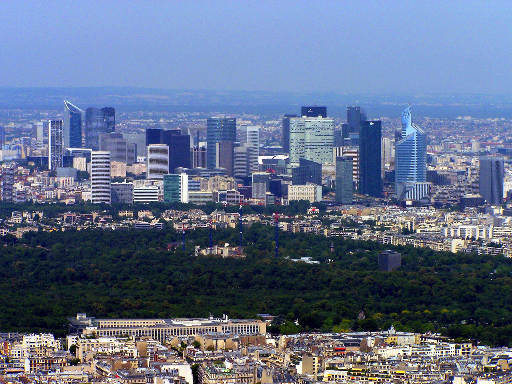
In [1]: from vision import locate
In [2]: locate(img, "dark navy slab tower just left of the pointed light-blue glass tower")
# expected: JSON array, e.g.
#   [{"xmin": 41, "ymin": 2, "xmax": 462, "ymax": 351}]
[{"xmin": 359, "ymin": 120, "xmax": 382, "ymax": 197}]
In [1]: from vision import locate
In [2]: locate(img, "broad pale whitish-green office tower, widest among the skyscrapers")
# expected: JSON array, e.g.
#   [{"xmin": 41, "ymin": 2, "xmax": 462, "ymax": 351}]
[{"xmin": 290, "ymin": 117, "xmax": 334, "ymax": 167}]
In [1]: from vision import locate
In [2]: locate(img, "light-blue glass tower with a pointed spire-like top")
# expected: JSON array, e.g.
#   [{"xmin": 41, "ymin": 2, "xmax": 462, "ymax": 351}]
[{"xmin": 395, "ymin": 107, "xmax": 427, "ymax": 200}]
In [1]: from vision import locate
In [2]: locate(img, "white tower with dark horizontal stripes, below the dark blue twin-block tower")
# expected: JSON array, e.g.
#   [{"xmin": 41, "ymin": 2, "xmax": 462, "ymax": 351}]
[{"xmin": 91, "ymin": 151, "xmax": 110, "ymax": 204}]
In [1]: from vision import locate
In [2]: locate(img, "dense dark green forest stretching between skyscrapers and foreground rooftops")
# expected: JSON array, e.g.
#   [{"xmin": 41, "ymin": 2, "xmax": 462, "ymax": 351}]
[{"xmin": 0, "ymin": 224, "xmax": 512, "ymax": 345}]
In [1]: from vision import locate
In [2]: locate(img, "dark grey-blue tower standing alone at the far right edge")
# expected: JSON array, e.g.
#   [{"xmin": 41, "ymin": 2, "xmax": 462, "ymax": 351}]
[{"xmin": 479, "ymin": 156, "xmax": 505, "ymax": 205}]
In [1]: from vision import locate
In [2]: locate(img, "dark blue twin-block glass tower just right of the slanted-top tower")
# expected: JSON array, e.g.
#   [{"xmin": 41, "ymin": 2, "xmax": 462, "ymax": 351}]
[{"xmin": 85, "ymin": 107, "xmax": 116, "ymax": 151}]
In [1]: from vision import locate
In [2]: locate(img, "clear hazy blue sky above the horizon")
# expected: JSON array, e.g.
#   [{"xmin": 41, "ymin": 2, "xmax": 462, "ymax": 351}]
[{"xmin": 0, "ymin": 0, "xmax": 512, "ymax": 93}]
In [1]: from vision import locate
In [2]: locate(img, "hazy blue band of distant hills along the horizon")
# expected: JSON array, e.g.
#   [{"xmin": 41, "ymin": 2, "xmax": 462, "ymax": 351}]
[{"xmin": 0, "ymin": 87, "xmax": 512, "ymax": 119}]
